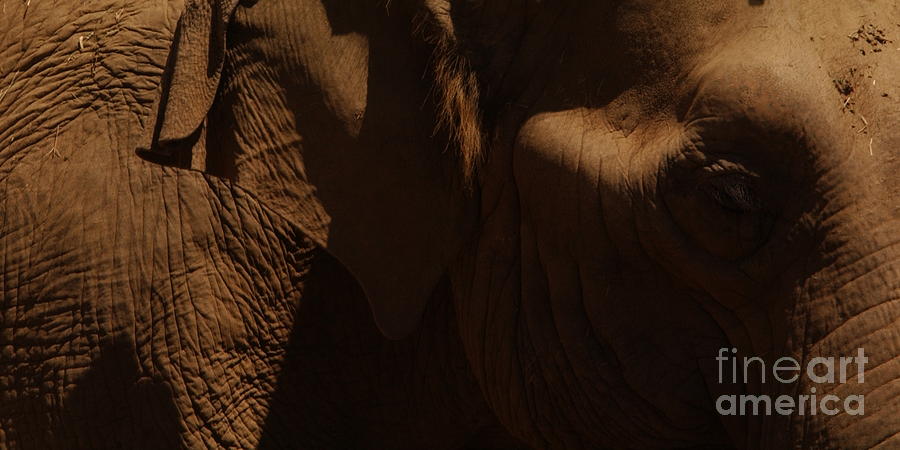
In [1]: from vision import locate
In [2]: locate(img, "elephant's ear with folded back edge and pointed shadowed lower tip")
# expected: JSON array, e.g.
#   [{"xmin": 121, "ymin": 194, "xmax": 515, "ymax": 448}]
[{"xmin": 143, "ymin": 0, "xmax": 474, "ymax": 336}]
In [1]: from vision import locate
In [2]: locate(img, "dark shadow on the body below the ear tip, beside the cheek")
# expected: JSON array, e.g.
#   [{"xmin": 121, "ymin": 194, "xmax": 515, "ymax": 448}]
[{"xmin": 257, "ymin": 252, "xmax": 527, "ymax": 450}]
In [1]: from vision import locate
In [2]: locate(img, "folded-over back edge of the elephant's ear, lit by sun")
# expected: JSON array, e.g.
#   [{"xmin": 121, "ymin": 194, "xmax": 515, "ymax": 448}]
[{"xmin": 138, "ymin": 0, "xmax": 240, "ymax": 165}]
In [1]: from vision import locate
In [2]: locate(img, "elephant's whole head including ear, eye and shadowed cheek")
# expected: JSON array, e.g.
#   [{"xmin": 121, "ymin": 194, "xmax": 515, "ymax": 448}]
[{"xmin": 144, "ymin": 0, "xmax": 900, "ymax": 448}]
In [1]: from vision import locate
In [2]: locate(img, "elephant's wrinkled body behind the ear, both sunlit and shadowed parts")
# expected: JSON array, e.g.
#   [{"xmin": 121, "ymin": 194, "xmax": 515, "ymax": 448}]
[{"xmin": 0, "ymin": 1, "xmax": 509, "ymax": 449}]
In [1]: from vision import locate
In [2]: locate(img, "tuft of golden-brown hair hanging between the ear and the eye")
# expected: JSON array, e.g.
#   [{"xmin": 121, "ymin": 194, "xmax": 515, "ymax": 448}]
[{"xmin": 415, "ymin": 0, "xmax": 485, "ymax": 190}]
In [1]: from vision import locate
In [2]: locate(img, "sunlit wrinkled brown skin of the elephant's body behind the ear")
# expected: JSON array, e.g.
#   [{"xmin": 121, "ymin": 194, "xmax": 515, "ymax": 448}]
[{"xmin": 0, "ymin": 2, "xmax": 316, "ymax": 448}]
